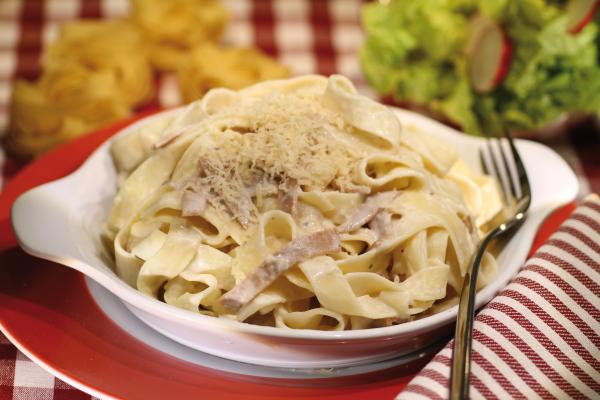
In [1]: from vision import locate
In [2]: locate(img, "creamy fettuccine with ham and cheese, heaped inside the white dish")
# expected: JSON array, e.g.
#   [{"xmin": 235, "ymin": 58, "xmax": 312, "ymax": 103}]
[{"xmin": 106, "ymin": 75, "xmax": 501, "ymax": 330}]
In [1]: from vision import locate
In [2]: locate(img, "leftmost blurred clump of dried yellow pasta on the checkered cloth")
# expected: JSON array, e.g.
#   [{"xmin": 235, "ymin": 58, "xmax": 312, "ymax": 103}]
[{"xmin": 7, "ymin": 21, "xmax": 154, "ymax": 158}]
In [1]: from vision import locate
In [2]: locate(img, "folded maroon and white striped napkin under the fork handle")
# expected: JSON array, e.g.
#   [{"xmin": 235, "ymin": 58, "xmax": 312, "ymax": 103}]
[{"xmin": 396, "ymin": 195, "xmax": 600, "ymax": 400}]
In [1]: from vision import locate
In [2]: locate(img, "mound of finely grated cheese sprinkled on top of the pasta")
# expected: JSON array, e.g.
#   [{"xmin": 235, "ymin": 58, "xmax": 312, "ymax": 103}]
[{"xmin": 191, "ymin": 93, "xmax": 362, "ymax": 227}]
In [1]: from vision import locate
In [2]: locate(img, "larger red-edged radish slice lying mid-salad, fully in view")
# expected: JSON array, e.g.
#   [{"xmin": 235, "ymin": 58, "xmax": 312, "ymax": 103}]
[{"xmin": 467, "ymin": 16, "xmax": 512, "ymax": 93}]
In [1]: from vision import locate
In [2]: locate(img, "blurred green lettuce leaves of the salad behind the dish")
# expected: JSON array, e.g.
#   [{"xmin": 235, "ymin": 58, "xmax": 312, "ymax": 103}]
[{"xmin": 360, "ymin": 0, "xmax": 600, "ymax": 134}]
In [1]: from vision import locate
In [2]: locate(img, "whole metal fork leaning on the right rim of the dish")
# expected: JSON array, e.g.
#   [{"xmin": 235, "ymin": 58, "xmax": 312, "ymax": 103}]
[{"xmin": 450, "ymin": 132, "xmax": 531, "ymax": 399}]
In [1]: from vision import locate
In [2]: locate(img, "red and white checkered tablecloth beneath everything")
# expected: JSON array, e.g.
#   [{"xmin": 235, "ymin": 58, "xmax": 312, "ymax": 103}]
[{"xmin": 0, "ymin": 0, "xmax": 600, "ymax": 399}]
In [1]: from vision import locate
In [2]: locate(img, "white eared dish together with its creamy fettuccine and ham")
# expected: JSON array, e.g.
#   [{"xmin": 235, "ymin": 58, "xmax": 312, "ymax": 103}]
[{"xmin": 12, "ymin": 75, "xmax": 577, "ymax": 368}]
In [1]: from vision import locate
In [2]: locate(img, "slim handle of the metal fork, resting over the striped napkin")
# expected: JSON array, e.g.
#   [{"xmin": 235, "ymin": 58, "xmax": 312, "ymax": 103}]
[{"xmin": 450, "ymin": 232, "xmax": 495, "ymax": 400}]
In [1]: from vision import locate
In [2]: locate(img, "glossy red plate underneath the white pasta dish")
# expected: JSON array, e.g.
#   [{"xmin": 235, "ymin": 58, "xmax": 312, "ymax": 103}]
[{"xmin": 0, "ymin": 115, "xmax": 572, "ymax": 399}]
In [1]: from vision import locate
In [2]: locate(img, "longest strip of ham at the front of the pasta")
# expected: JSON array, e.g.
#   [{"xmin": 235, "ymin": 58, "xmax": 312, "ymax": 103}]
[{"xmin": 219, "ymin": 229, "xmax": 340, "ymax": 312}]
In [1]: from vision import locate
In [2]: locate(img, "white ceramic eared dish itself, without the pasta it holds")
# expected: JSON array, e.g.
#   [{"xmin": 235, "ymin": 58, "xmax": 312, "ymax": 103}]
[{"xmin": 12, "ymin": 109, "xmax": 578, "ymax": 368}]
